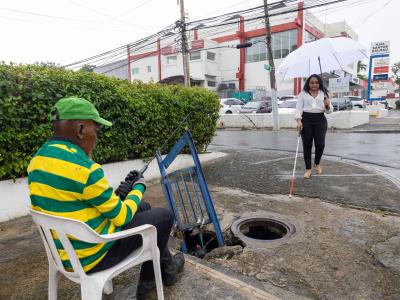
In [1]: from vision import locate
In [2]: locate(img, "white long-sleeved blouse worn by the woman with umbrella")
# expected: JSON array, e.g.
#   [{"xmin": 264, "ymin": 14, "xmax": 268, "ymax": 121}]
[{"xmin": 295, "ymin": 90, "xmax": 333, "ymax": 120}]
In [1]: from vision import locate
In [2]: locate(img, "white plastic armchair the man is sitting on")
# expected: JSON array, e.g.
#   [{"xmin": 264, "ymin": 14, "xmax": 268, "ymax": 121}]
[{"xmin": 30, "ymin": 209, "xmax": 164, "ymax": 300}]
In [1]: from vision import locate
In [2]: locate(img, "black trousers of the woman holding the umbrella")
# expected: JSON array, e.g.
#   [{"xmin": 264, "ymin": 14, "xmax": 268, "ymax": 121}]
[{"xmin": 301, "ymin": 112, "xmax": 328, "ymax": 170}]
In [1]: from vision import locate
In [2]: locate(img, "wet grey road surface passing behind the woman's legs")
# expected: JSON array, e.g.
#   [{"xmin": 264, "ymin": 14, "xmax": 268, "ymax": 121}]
[{"xmin": 210, "ymin": 130, "xmax": 400, "ymax": 186}]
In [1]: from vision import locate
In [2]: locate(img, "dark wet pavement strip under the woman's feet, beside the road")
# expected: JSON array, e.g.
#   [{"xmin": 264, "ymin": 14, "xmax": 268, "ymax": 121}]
[{"xmin": 205, "ymin": 146, "xmax": 400, "ymax": 214}]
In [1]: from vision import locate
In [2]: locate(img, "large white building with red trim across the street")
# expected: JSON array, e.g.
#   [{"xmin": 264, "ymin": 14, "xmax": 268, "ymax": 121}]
[{"xmin": 96, "ymin": 2, "xmax": 358, "ymax": 95}]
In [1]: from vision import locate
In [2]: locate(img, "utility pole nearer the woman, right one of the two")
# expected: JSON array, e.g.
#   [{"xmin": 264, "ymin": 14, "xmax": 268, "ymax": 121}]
[{"xmin": 264, "ymin": 0, "xmax": 279, "ymax": 130}]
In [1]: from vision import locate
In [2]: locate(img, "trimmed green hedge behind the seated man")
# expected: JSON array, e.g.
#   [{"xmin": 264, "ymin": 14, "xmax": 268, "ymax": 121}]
[{"xmin": 0, "ymin": 64, "xmax": 219, "ymax": 179}]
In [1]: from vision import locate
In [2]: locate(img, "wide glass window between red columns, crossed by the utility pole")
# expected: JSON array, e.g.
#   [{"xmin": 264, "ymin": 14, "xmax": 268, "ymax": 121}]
[{"xmin": 246, "ymin": 29, "xmax": 297, "ymax": 63}]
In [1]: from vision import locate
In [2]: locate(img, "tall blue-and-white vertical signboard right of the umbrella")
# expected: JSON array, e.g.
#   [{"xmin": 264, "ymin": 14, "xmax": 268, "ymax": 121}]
[{"xmin": 368, "ymin": 41, "xmax": 390, "ymax": 101}]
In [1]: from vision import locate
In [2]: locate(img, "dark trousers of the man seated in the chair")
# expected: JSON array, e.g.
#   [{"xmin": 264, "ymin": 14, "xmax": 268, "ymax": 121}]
[{"xmin": 88, "ymin": 202, "xmax": 174, "ymax": 280}]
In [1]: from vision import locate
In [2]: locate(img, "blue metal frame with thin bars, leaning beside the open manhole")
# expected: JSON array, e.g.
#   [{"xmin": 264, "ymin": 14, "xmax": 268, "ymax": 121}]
[{"xmin": 156, "ymin": 131, "xmax": 225, "ymax": 252}]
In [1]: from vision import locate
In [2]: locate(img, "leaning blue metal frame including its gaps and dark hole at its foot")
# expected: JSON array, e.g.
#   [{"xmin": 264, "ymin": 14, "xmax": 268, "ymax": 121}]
[{"xmin": 157, "ymin": 131, "xmax": 225, "ymax": 258}]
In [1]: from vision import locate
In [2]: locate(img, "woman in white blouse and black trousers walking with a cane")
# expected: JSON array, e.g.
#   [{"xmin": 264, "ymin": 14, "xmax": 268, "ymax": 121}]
[{"xmin": 295, "ymin": 74, "xmax": 333, "ymax": 178}]
